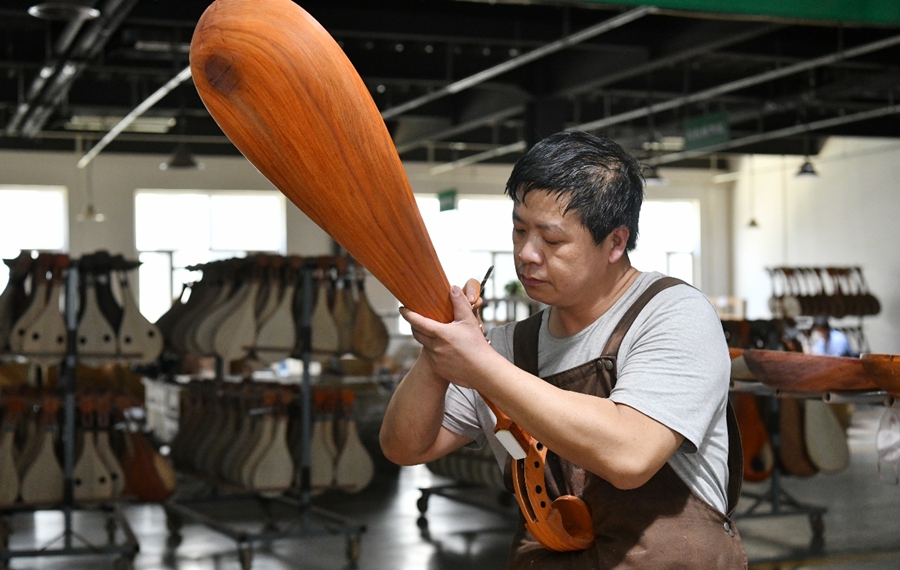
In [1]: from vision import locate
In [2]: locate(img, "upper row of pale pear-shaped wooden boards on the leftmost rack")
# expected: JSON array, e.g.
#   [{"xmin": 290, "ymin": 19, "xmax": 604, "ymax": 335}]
[{"xmin": 0, "ymin": 251, "xmax": 163, "ymax": 367}]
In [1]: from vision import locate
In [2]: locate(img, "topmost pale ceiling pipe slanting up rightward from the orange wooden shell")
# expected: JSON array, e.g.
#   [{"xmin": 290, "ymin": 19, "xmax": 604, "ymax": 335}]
[{"xmin": 381, "ymin": 6, "xmax": 656, "ymax": 120}]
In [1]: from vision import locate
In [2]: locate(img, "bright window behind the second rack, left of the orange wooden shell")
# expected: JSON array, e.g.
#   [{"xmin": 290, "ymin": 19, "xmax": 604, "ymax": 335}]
[{"xmin": 134, "ymin": 190, "xmax": 286, "ymax": 321}]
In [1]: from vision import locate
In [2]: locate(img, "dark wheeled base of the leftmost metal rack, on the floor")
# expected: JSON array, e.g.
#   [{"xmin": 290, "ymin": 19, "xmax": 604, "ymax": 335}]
[{"xmin": 0, "ymin": 503, "xmax": 140, "ymax": 570}]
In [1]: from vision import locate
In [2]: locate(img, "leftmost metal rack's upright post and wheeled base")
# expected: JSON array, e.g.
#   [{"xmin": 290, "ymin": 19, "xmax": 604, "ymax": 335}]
[{"xmin": 0, "ymin": 262, "xmax": 139, "ymax": 570}]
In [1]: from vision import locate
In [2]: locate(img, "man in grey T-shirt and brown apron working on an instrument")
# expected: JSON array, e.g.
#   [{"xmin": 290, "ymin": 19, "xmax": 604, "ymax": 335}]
[{"xmin": 381, "ymin": 132, "xmax": 747, "ymax": 570}]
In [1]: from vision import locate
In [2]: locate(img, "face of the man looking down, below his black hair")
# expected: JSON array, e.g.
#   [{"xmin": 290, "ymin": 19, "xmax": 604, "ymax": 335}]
[{"xmin": 513, "ymin": 190, "xmax": 611, "ymax": 308}]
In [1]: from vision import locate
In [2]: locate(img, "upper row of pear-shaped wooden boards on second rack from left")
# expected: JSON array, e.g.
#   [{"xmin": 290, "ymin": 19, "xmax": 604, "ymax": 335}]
[{"xmin": 156, "ymin": 254, "xmax": 389, "ymax": 368}]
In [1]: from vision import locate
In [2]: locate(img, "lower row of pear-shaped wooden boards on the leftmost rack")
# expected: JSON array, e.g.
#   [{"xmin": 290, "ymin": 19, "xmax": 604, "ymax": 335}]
[{"xmin": 0, "ymin": 388, "xmax": 176, "ymax": 506}]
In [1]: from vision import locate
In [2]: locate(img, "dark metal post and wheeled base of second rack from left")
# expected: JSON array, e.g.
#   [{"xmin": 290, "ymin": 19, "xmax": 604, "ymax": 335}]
[{"xmin": 163, "ymin": 263, "xmax": 366, "ymax": 570}]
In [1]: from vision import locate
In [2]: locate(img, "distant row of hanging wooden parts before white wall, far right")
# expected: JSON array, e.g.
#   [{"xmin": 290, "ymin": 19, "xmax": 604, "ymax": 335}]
[{"xmin": 767, "ymin": 267, "xmax": 881, "ymax": 319}]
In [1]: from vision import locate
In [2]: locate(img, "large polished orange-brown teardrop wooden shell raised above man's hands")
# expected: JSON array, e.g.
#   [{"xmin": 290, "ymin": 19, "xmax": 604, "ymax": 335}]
[{"xmin": 190, "ymin": 0, "xmax": 453, "ymax": 322}]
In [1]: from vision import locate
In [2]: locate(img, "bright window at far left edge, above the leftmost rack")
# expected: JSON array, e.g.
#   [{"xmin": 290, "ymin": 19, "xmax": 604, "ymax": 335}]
[{"xmin": 0, "ymin": 185, "xmax": 68, "ymax": 290}]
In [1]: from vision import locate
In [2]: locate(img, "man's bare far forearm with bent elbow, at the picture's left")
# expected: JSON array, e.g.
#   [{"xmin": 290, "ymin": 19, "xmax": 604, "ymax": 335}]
[{"xmin": 379, "ymin": 358, "xmax": 449, "ymax": 465}]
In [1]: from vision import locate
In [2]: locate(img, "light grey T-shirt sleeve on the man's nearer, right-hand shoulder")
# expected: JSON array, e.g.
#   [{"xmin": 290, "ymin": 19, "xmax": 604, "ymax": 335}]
[{"xmin": 610, "ymin": 286, "xmax": 731, "ymax": 453}]
